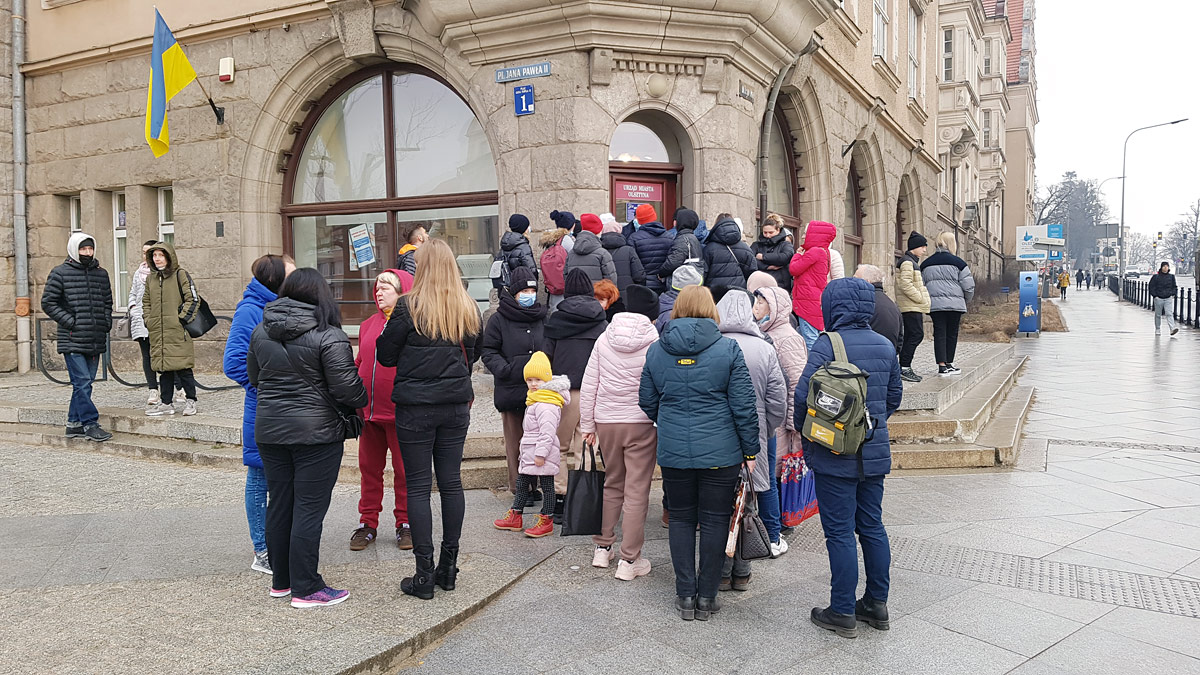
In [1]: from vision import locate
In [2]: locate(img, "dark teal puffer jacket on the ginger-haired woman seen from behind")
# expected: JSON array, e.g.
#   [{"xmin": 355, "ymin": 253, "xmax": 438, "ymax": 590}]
[{"xmin": 637, "ymin": 318, "xmax": 758, "ymax": 468}]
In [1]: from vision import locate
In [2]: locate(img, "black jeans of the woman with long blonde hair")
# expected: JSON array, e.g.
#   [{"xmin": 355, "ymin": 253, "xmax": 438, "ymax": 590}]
[{"xmin": 396, "ymin": 404, "xmax": 470, "ymax": 556}]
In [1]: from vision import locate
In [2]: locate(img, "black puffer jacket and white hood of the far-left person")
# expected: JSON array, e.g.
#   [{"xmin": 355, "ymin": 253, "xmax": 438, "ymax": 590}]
[{"xmin": 42, "ymin": 233, "xmax": 113, "ymax": 354}]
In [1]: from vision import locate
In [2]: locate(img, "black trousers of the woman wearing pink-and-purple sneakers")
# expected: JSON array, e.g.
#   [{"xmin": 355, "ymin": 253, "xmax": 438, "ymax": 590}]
[{"xmin": 258, "ymin": 441, "xmax": 343, "ymax": 597}]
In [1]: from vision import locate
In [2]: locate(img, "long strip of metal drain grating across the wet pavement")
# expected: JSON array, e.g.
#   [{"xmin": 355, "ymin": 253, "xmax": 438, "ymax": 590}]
[{"xmin": 792, "ymin": 530, "xmax": 1200, "ymax": 619}]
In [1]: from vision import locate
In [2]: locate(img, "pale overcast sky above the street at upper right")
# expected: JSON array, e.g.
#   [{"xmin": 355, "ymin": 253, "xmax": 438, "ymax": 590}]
[{"xmin": 1036, "ymin": 0, "xmax": 1200, "ymax": 233}]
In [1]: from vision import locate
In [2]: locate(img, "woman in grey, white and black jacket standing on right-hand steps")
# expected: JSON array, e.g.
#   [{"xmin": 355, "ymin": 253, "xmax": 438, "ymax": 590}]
[{"xmin": 920, "ymin": 232, "xmax": 974, "ymax": 375}]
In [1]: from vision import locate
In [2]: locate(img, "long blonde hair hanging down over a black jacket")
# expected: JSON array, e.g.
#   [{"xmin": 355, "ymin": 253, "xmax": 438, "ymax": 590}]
[{"xmin": 397, "ymin": 239, "xmax": 479, "ymax": 342}]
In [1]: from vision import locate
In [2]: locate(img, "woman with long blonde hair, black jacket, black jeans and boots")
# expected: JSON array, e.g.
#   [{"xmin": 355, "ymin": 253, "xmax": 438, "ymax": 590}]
[{"xmin": 376, "ymin": 239, "xmax": 482, "ymax": 599}]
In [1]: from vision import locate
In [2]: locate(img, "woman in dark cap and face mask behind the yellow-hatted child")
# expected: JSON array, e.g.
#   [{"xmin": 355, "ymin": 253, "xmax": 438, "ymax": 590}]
[{"xmin": 480, "ymin": 268, "xmax": 546, "ymax": 501}]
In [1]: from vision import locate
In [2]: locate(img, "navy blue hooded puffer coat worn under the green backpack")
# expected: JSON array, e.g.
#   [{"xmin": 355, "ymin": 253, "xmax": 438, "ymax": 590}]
[{"xmin": 794, "ymin": 277, "xmax": 904, "ymax": 478}]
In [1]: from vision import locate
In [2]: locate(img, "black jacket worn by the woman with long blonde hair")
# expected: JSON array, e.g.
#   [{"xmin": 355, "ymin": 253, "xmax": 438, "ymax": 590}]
[{"xmin": 376, "ymin": 297, "xmax": 484, "ymax": 406}]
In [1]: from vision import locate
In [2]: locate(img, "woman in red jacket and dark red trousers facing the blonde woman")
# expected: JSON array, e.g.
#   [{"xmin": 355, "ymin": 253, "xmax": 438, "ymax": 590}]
[{"xmin": 350, "ymin": 269, "xmax": 413, "ymax": 551}]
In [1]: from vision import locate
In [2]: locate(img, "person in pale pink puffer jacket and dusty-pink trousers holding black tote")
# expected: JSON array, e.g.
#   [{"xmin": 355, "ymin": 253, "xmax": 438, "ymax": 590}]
[{"xmin": 580, "ymin": 285, "xmax": 659, "ymax": 581}]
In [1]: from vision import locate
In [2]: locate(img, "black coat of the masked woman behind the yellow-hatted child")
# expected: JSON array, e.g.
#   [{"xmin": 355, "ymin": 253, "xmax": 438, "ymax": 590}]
[{"xmin": 480, "ymin": 293, "xmax": 546, "ymax": 412}]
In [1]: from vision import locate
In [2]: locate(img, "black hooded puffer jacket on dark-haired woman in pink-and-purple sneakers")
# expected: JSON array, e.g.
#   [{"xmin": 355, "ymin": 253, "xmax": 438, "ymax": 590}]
[{"xmin": 246, "ymin": 298, "xmax": 367, "ymax": 446}]
